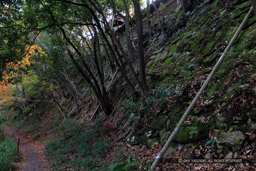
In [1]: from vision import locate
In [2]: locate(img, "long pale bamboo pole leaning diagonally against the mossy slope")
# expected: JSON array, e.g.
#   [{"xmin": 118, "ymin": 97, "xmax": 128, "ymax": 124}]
[{"xmin": 151, "ymin": 7, "xmax": 253, "ymax": 171}]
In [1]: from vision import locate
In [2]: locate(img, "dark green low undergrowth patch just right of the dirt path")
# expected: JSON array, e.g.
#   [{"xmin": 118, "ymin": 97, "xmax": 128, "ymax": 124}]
[{"xmin": 46, "ymin": 120, "xmax": 110, "ymax": 170}]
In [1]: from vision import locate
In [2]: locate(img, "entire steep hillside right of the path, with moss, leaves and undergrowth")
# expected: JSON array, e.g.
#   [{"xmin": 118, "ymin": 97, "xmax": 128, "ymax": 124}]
[{"xmin": 2, "ymin": 0, "xmax": 256, "ymax": 170}]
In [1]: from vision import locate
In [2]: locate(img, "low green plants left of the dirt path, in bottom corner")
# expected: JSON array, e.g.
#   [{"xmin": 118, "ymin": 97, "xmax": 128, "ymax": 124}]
[{"xmin": 0, "ymin": 138, "xmax": 17, "ymax": 171}]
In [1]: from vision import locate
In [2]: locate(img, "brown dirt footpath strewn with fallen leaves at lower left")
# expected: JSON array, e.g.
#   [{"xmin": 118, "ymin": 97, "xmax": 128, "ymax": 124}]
[{"xmin": 4, "ymin": 126, "xmax": 50, "ymax": 171}]
